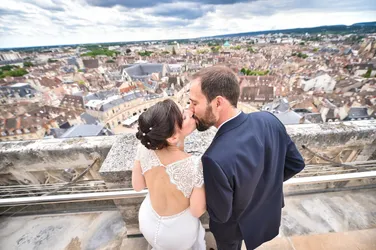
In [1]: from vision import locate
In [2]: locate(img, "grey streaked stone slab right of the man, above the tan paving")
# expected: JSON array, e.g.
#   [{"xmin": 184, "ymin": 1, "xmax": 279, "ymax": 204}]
[{"xmin": 281, "ymin": 189, "xmax": 376, "ymax": 236}]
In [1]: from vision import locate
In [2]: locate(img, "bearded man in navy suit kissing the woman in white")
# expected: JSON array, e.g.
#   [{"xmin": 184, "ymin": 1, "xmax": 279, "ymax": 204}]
[{"xmin": 190, "ymin": 66, "xmax": 305, "ymax": 250}]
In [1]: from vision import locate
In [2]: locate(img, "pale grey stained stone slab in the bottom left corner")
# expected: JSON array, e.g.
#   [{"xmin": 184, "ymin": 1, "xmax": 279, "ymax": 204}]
[{"xmin": 0, "ymin": 211, "xmax": 126, "ymax": 250}]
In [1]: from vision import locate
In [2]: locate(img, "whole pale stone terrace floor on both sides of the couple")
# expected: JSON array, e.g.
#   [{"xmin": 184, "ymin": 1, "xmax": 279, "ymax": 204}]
[{"xmin": 0, "ymin": 189, "xmax": 376, "ymax": 250}]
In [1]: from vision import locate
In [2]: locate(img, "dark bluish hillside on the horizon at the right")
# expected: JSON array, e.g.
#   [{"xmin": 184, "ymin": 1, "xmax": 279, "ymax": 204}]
[{"xmin": 210, "ymin": 22, "xmax": 376, "ymax": 38}]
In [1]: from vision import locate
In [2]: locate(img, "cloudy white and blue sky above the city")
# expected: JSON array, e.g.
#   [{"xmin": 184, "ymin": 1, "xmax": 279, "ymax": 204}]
[{"xmin": 0, "ymin": 0, "xmax": 376, "ymax": 48}]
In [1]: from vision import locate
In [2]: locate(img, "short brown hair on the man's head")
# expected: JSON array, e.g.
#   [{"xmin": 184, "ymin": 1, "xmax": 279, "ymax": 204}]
[{"xmin": 192, "ymin": 66, "xmax": 240, "ymax": 107}]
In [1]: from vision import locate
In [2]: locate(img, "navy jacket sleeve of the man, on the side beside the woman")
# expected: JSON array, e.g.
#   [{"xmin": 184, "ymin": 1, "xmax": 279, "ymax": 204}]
[{"xmin": 202, "ymin": 155, "xmax": 233, "ymax": 223}]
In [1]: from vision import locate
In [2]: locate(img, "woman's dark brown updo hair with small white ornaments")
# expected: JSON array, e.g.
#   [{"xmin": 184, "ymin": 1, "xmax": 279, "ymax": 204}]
[{"xmin": 136, "ymin": 99, "xmax": 183, "ymax": 150}]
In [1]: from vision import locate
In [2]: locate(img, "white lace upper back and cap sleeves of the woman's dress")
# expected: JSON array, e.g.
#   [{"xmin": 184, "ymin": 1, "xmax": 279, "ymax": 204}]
[{"xmin": 136, "ymin": 145, "xmax": 204, "ymax": 198}]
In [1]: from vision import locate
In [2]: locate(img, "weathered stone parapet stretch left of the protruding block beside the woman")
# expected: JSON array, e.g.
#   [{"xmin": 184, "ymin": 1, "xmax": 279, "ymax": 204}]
[{"xmin": 0, "ymin": 136, "xmax": 116, "ymax": 173}]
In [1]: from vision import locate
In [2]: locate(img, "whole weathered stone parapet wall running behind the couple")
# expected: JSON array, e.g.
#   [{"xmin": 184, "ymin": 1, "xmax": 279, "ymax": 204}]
[{"xmin": 0, "ymin": 121, "xmax": 376, "ymax": 227}]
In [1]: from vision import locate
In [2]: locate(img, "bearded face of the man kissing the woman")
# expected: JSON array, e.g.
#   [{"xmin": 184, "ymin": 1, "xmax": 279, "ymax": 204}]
[{"xmin": 189, "ymin": 79, "xmax": 217, "ymax": 131}]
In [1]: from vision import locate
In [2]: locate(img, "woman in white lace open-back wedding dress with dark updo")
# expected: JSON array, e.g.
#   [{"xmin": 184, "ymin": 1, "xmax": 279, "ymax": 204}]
[{"xmin": 132, "ymin": 100, "xmax": 206, "ymax": 250}]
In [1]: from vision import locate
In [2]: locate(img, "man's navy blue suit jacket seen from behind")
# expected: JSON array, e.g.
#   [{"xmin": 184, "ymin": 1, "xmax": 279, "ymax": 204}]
[{"xmin": 202, "ymin": 112, "xmax": 305, "ymax": 249}]
